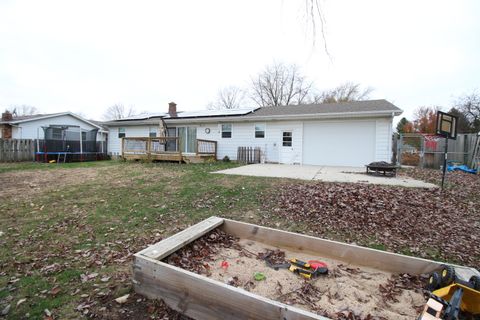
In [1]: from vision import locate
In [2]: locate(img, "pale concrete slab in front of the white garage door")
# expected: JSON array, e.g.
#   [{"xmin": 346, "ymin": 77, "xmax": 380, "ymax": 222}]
[{"xmin": 214, "ymin": 164, "xmax": 437, "ymax": 188}]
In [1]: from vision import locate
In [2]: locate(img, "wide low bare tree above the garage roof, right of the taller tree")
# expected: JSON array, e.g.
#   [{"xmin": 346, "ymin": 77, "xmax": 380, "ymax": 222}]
[{"xmin": 313, "ymin": 82, "xmax": 373, "ymax": 103}]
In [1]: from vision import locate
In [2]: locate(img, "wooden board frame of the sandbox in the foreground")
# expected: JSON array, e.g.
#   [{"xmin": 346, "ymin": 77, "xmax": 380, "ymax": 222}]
[{"xmin": 133, "ymin": 217, "xmax": 478, "ymax": 320}]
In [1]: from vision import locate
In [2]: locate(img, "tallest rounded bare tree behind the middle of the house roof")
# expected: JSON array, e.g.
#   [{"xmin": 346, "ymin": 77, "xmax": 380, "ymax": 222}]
[{"xmin": 251, "ymin": 63, "xmax": 312, "ymax": 107}]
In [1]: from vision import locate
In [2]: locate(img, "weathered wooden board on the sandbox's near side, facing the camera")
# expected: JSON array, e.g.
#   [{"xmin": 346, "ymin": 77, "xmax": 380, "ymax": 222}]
[{"xmin": 133, "ymin": 254, "xmax": 327, "ymax": 320}]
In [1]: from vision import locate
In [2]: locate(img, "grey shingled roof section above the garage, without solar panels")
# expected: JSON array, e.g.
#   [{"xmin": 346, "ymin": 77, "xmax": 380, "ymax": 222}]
[{"xmin": 245, "ymin": 99, "xmax": 402, "ymax": 117}]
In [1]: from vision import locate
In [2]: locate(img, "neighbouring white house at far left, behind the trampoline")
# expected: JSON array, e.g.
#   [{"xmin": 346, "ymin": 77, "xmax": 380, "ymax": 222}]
[{"xmin": 0, "ymin": 112, "xmax": 108, "ymax": 141}]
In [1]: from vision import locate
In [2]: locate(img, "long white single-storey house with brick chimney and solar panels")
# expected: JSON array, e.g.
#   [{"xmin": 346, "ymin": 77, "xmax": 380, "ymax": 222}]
[{"xmin": 105, "ymin": 100, "xmax": 402, "ymax": 166}]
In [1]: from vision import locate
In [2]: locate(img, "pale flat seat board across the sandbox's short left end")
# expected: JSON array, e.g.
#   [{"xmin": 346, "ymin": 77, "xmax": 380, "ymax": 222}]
[{"xmin": 139, "ymin": 216, "xmax": 223, "ymax": 260}]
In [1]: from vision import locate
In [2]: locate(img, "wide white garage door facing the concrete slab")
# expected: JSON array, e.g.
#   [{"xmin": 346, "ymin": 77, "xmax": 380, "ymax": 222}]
[{"xmin": 303, "ymin": 121, "xmax": 375, "ymax": 167}]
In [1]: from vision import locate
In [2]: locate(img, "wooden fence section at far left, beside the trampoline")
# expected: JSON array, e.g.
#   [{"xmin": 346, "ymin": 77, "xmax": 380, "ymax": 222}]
[{"xmin": 0, "ymin": 139, "xmax": 35, "ymax": 162}]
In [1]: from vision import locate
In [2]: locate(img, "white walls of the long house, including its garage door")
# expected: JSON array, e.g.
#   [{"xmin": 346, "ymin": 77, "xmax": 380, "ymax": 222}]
[{"xmin": 108, "ymin": 118, "xmax": 392, "ymax": 166}]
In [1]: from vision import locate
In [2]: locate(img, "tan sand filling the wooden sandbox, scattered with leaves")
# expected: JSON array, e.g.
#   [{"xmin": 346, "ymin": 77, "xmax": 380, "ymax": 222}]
[{"xmin": 204, "ymin": 239, "xmax": 425, "ymax": 319}]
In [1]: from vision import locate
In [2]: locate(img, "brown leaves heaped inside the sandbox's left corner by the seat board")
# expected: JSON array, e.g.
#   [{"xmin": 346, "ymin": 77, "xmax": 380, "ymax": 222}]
[{"xmin": 164, "ymin": 229, "xmax": 240, "ymax": 275}]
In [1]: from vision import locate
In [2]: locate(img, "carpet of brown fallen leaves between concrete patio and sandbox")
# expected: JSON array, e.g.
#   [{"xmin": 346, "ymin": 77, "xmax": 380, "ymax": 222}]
[{"xmin": 264, "ymin": 169, "xmax": 480, "ymax": 268}]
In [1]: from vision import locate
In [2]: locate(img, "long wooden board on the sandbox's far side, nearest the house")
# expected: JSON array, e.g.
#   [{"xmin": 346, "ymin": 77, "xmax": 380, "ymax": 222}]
[{"xmin": 221, "ymin": 219, "xmax": 441, "ymax": 274}]
